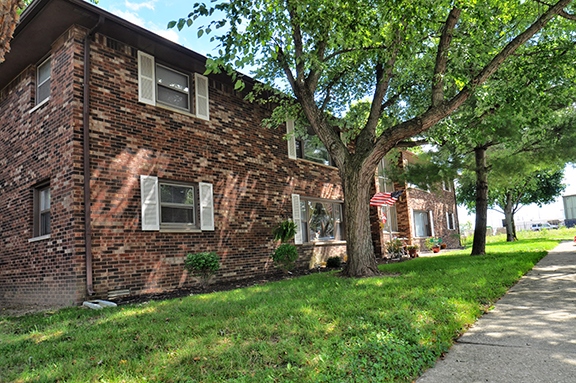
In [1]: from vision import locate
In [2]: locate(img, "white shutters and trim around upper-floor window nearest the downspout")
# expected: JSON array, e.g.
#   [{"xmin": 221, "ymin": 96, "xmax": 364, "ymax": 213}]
[{"xmin": 138, "ymin": 51, "xmax": 210, "ymax": 121}]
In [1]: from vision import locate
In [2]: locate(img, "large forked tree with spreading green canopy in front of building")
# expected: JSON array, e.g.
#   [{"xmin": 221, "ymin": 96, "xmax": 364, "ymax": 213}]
[{"xmin": 169, "ymin": 0, "xmax": 572, "ymax": 276}]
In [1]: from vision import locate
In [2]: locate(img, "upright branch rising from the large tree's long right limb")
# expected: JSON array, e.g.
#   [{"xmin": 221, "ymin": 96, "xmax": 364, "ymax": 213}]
[{"xmin": 432, "ymin": 7, "xmax": 462, "ymax": 106}]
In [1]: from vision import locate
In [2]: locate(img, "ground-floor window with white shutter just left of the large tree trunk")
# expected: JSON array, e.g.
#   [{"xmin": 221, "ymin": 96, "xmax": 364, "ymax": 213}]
[{"xmin": 292, "ymin": 194, "xmax": 344, "ymax": 244}]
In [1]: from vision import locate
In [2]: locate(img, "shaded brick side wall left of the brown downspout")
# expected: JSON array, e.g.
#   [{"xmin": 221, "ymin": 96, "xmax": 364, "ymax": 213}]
[{"xmin": 0, "ymin": 27, "xmax": 84, "ymax": 307}]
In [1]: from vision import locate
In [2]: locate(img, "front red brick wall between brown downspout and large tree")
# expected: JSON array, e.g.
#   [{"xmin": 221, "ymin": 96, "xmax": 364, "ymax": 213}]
[{"xmin": 85, "ymin": 31, "xmax": 342, "ymax": 297}]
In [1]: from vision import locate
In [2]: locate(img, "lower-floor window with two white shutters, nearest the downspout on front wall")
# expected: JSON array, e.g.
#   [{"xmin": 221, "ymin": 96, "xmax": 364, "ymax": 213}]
[{"xmin": 140, "ymin": 175, "xmax": 214, "ymax": 231}]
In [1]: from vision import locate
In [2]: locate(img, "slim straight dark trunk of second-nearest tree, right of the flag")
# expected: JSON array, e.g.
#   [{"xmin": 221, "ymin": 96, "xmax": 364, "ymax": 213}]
[{"xmin": 470, "ymin": 146, "xmax": 488, "ymax": 255}]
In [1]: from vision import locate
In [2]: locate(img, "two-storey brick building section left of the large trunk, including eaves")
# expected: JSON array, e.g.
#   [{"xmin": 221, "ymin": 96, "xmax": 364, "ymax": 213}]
[{"xmin": 0, "ymin": 0, "xmax": 460, "ymax": 306}]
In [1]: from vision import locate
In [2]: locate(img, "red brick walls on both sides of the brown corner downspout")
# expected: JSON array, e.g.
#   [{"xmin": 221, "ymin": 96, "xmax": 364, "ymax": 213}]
[{"xmin": 0, "ymin": 28, "xmax": 345, "ymax": 306}]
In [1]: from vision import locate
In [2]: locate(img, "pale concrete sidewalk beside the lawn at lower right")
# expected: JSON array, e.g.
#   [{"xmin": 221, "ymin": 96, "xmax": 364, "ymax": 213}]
[{"xmin": 416, "ymin": 242, "xmax": 576, "ymax": 383}]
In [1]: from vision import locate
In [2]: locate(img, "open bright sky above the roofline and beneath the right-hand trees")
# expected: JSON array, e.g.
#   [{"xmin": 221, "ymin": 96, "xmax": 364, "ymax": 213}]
[{"xmin": 97, "ymin": 0, "xmax": 576, "ymax": 227}]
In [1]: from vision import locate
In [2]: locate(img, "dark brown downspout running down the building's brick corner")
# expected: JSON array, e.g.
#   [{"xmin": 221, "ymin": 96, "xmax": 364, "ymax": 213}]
[{"xmin": 82, "ymin": 16, "xmax": 104, "ymax": 295}]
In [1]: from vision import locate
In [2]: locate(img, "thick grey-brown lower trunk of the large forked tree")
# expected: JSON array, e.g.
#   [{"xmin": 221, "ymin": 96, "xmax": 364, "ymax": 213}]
[{"xmin": 340, "ymin": 165, "xmax": 380, "ymax": 277}]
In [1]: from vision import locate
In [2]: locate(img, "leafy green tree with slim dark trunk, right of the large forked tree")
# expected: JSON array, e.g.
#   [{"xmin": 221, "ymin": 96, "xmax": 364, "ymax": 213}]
[{"xmin": 418, "ymin": 27, "xmax": 576, "ymax": 255}]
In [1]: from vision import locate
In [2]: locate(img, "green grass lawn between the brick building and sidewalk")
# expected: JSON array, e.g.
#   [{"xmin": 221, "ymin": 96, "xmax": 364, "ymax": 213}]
[{"xmin": 0, "ymin": 234, "xmax": 571, "ymax": 382}]
